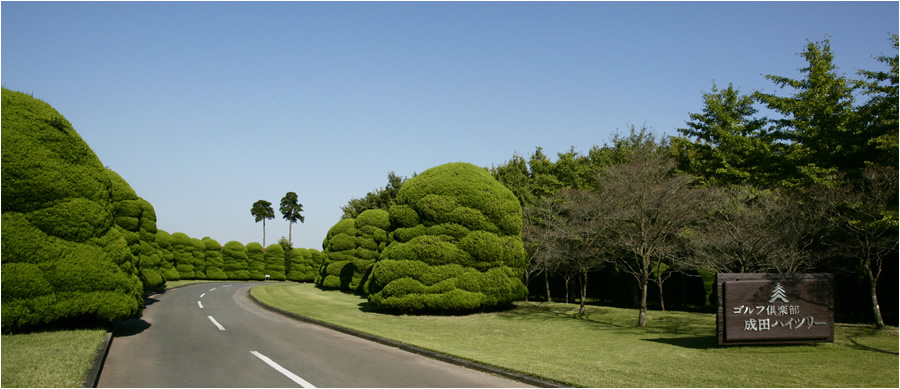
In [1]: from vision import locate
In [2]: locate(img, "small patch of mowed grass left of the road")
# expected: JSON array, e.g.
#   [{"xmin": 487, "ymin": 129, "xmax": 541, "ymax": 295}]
[{"xmin": 0, "ymin": 329, "xmax": 106, "ymax": 388}]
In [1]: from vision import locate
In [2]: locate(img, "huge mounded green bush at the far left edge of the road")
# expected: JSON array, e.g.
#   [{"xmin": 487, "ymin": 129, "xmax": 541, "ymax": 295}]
[{"xmin": 0, "ymin": 89, "xmax": 143, "ymax": 331}]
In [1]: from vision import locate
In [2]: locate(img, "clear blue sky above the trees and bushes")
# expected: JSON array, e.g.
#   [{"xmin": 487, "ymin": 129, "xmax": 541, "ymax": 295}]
[{"xmin": 0, "ymin": 1, "xmax": 898, "ymax": 249}]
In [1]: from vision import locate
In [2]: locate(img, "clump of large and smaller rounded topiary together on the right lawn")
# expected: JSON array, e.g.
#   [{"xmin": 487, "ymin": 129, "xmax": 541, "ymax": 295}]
[{"xmin": 326, "ymin": 162, "xmax": 527, "ymax": 313}]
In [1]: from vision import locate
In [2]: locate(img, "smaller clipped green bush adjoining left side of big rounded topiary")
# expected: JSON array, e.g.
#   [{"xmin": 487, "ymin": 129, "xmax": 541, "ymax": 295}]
[{"xmin": 316, "ymin": 209, "xmax": 390, "ymax": 292}]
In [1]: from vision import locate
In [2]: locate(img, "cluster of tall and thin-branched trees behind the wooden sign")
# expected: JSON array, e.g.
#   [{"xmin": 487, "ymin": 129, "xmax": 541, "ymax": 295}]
[{"xmin": 491, "ymin": 36, "xmax": 898, "ymax": 327}]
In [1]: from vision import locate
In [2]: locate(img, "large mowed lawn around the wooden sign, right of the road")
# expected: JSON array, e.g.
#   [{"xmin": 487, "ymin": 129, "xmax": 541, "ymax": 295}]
[{"xmin": 251, "ymin": 284, "xmax": 900, "ymax": 388}]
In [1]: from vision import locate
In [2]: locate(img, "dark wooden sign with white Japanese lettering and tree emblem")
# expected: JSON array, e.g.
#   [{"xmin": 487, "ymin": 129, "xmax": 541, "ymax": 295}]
[{"xmin": 716, "ymin": 273, "xmax": 834, "ymax": 345}]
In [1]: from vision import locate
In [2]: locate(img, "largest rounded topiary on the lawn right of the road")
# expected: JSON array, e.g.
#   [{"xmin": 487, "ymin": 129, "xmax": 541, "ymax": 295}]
[{"xmin": 367, "ymin": 163, "xmax": 527, "ymax": 312}]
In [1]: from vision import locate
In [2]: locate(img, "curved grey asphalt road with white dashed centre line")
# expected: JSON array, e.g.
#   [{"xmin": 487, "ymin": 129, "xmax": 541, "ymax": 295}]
[{"xmin": 98, "ymin": 282, "xmax": 526, "ymax": 388}]
